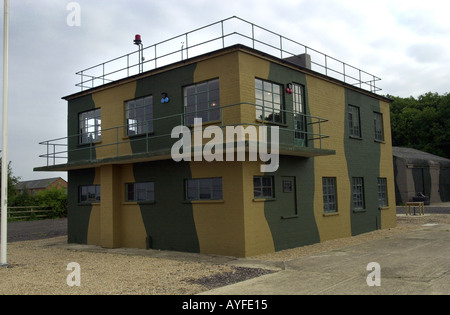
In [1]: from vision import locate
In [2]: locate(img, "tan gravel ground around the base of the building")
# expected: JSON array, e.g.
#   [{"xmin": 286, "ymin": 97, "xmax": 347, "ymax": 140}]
[{"xmin": 0, "ymin": 214, "xmax": 450, "ymax": 295}]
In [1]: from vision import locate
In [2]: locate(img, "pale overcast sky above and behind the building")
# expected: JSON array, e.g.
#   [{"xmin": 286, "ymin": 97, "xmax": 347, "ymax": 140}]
[{"xmin": 0, "ymin": 0, "xmax": 450, "ymax": 180}]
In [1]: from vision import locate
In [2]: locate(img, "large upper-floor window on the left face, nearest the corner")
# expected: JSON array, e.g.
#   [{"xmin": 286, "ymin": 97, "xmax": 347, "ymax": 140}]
[{"xmin": 184, "ymin": 79, "xmax": 220, "ymax": 125}]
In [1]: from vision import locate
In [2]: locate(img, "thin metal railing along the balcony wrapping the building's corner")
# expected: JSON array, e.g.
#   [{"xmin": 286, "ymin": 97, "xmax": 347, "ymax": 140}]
[{"xmin": 40, "ymin": 103, "xmax": 329, "ymax": 167}]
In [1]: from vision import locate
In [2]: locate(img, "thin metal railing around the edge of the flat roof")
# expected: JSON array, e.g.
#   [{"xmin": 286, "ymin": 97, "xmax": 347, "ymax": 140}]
[{"xmin": 76, "ymin": 16, "xmax": 381, "ymax": 93}]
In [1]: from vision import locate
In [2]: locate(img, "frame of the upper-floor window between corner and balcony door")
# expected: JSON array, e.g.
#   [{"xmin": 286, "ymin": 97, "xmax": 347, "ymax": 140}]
[{"xmin": 255, "ymin": 78, "xmax": 286, "ymax": 124}]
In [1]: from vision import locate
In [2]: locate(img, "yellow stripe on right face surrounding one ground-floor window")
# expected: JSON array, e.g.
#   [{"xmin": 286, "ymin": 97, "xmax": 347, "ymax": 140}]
[{"xmin": 306, "ymin": 75, "xmax": 351, "ymax": 241}]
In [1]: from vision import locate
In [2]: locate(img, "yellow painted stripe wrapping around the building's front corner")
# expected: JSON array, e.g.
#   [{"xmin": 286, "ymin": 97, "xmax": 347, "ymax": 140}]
[{"xmin": 191, "ymin": 52, "xmax": 274, "ymax": 256}]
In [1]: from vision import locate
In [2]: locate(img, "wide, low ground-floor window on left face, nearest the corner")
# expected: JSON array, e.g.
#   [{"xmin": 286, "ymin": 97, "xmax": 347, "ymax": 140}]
[{"xmin": 185, "ymin": 178, "xmax": 223, "ymax": 200}]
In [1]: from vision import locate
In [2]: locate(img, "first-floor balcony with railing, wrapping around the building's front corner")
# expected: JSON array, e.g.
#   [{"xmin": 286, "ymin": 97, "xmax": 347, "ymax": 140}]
[{"xmin": 35, "ymin": 103, "xmax": 335, "ymax": 171}]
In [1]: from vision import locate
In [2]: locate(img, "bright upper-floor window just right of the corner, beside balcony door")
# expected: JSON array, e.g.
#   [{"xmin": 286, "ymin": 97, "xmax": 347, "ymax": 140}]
[{"xmin": 255, "ymin": 79, "xmax": 284, "ymax": 123}]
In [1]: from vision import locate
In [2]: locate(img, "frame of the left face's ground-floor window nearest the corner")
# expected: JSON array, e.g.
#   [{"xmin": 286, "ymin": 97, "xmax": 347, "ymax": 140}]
[{"xmin": 184, "ymin": 177, "xmax": 223, "ymax": 202}]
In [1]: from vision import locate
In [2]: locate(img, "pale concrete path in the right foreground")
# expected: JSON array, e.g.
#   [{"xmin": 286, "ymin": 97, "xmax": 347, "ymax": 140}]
[{"xmin": 202, "ymin": 224, "xmax": 450, "ymax": 295}]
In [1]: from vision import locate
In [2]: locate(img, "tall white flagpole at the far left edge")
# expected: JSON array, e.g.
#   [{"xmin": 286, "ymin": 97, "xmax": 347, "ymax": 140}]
[{"xmin": 0, "ymin": 0, "xmax": 9, "ymax": 267}]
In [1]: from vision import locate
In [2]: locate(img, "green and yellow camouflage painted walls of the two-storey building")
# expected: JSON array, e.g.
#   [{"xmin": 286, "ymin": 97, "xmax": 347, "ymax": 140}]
[{"xmin": 65, "ymin": 47, "xmax": 395, "ymax": 256}]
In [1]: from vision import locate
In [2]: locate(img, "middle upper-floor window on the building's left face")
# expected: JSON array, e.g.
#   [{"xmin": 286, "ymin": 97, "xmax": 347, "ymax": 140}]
[{"xmin": 125, "ymin": 96, "xmax": 153, "ymax": 136}]
